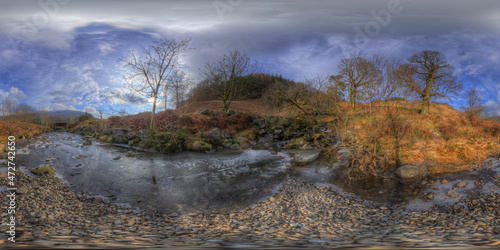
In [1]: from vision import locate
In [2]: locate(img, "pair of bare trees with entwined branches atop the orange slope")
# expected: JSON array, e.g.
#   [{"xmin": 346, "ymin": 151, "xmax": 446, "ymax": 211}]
[{"xmin": 332, "ymin": 50, "xmax": 462, "ymax": 115}]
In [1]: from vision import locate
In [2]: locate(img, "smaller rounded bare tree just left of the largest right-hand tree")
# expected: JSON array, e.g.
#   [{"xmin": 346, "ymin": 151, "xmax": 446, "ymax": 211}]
[{"xmin": 331, "ymin": 54, "xmax": 381, "ymax": 110}]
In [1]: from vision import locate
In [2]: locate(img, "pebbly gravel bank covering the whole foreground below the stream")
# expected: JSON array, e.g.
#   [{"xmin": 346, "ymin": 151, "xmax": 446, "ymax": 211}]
[{"xmin": 0, "ymin": 172, "xmax": 500, "ymax": 248}]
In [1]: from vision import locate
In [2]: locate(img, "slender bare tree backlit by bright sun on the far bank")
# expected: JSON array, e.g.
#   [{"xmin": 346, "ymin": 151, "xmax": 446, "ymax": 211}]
[{"xmin": 120, "ymin": 38, "xmax": 189, "ymax": 135}]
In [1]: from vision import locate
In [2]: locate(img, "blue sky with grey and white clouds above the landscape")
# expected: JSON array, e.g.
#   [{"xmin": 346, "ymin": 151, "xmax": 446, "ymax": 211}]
[{"xmin": 0, "ymin": 0, "xmax": 500, "ymax": 116}]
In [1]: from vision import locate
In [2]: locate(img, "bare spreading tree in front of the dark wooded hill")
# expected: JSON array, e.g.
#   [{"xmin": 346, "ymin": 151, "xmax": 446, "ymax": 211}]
[{"xmin": 201, "ymin": 50, "xmax": 260, "ymax": 110}]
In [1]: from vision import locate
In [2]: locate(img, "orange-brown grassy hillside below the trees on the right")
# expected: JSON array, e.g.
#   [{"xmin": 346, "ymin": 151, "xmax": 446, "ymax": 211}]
[{"xmin": 342, "ymin": 101, "xmax": 500, "ymax": 173}]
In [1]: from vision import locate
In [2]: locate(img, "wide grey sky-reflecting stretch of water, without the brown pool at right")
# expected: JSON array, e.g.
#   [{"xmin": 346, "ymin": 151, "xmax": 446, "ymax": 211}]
[{"xmin": 20, "ymin": 133, "xmax": 332, "ymax": 213}]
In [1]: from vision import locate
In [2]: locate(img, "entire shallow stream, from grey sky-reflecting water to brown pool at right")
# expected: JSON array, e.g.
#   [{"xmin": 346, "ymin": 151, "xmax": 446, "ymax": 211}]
[{"xmin": 9, "ymin": 132, "xmax": 500, "ymax": 214}]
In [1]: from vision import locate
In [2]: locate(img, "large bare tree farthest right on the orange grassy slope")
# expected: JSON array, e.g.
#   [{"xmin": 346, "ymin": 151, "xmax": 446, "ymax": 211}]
[{"xmin": 401, "ymin": 50, "xmax": 462, "ymax": 115}]
